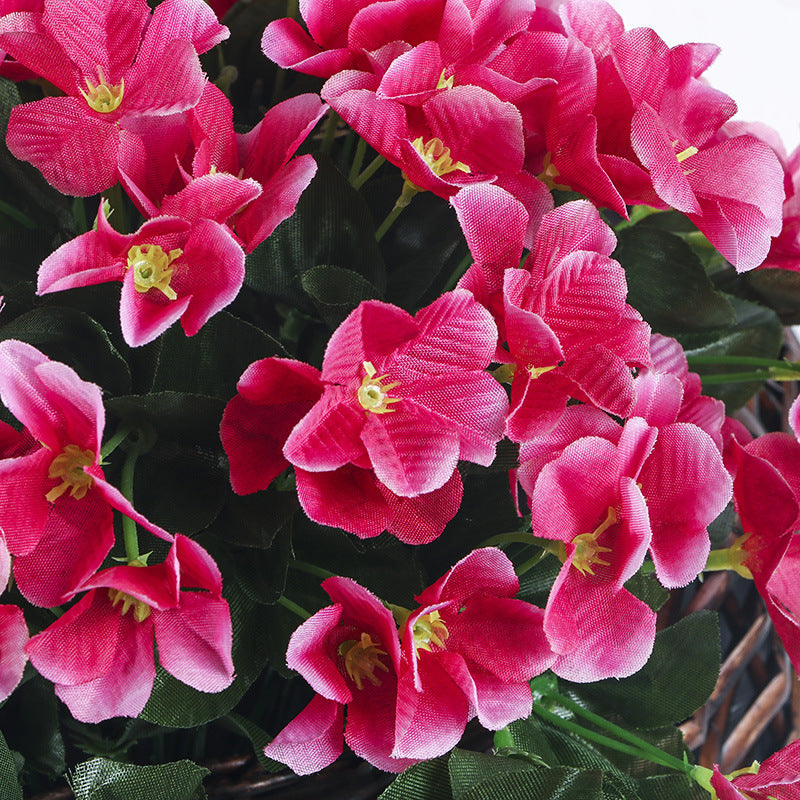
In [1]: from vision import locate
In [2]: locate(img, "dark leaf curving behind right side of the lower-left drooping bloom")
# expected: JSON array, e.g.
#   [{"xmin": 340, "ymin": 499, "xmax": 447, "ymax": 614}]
[{"xmin": 140, "ymin": 572, "xmax": 274, "ymax": 728}]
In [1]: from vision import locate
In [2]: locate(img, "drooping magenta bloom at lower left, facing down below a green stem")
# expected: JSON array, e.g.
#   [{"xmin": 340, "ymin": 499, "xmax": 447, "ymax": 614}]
[{"xmin": 26, "ymin": 534, "xmax": 233, "ymax": 722}]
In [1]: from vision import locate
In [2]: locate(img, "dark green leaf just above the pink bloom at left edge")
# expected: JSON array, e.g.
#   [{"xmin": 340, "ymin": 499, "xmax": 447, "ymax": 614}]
[{"xmin": 0, "ymin": 306, "xmax": 131, "ymax": 394}]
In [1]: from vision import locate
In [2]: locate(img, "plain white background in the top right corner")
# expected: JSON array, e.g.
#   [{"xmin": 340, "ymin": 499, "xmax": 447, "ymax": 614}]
[{"xmin": 610, "ymin": 0, "xmax": 800, "ymax": 152}]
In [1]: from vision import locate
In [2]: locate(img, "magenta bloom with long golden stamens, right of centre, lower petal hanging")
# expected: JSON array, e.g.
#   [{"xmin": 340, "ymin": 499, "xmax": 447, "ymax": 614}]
[{"xmin": 530, "ymin": 420, "xmax": 656, "ymax": 681}]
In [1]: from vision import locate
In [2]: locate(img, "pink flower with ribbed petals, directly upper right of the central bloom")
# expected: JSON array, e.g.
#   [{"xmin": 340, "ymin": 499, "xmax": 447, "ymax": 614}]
[{"xmin": 452, "ymin": 195, "xmax": 650, "ymax": 441}]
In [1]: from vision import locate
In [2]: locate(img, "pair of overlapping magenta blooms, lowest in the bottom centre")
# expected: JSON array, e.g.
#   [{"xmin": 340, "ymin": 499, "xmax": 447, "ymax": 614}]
[{"xmin": 265, "ymin": 549, "xmax": 553, "ymax": 774}]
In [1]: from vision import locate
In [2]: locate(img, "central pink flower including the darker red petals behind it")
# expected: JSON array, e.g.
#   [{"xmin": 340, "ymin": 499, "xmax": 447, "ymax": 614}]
[{"xmin": 220, "ymin": 292, "xmax": 507, "ymax": 544}]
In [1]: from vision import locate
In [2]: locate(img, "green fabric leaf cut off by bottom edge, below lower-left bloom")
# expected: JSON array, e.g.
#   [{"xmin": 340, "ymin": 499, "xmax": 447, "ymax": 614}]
[{"xmin": 70, "ymin": 758, "xmax": 209, "ymax": 800}]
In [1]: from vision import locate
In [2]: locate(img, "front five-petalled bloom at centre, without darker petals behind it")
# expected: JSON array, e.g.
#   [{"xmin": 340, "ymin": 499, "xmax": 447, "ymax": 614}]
[{"xmin": 283, "ymin": 291, "xmax": 508, "ymax": 497}]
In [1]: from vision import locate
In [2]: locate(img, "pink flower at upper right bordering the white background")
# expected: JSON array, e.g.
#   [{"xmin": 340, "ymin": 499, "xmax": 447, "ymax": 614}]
[{"xmin": 553, "ymin": 1, "xmax": 784, "ymax": 272}]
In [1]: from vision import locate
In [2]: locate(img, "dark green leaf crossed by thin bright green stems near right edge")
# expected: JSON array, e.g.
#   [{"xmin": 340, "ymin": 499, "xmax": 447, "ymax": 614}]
[{"xmin": 677, "ymin": 297, "xmax": 783, "ymax": 414}]
